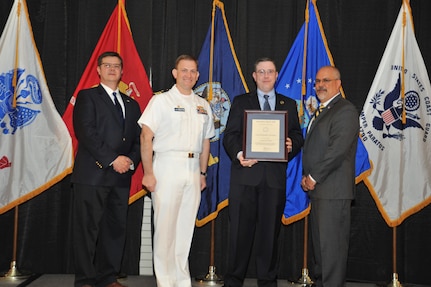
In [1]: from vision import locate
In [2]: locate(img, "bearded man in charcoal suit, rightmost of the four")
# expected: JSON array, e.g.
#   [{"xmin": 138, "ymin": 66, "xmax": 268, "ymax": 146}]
[{"xmin": 301, "ymin": 66, "xmax": 359, "ymax": 287}]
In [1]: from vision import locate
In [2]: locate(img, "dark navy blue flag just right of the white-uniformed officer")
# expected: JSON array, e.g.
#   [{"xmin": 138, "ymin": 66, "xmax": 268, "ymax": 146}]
[{"xmin": 195, "ymin": 0, "xmax": 248, "ymax": 226}]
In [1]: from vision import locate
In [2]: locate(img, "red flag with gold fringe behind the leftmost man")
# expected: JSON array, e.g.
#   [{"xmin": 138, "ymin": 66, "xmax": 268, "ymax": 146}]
[{"xmin": 63, "ymin": 0, "xmax": 153, "ymax": 203}]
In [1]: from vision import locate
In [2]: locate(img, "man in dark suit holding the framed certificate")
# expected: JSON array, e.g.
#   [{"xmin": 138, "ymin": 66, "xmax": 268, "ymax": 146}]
[{"xmin": 223, "ymin": 58, "xmax": 304, "ymax": 287}]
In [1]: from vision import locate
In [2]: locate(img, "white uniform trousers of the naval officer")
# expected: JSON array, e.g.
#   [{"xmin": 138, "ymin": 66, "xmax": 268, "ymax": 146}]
[{"xmin": 151, "ymin": 152, "xmax": 201, "ymax": 287}]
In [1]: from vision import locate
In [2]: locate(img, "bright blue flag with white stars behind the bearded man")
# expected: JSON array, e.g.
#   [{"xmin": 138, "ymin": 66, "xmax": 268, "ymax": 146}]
[{"xmin": 275, "ymin": 0, "xmax": 370, "ymax": 224}]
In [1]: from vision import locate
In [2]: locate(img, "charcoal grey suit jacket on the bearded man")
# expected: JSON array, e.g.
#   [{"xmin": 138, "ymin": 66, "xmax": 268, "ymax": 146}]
[{"xmin": 302, "ymin": 95, "xmax": 359, "ymax": 199}]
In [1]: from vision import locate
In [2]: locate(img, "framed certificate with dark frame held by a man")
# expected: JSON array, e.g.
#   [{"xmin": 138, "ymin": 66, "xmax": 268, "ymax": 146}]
[{"xmin": 243, "ymin": 110, "xmax": 288, "ymax": 162}]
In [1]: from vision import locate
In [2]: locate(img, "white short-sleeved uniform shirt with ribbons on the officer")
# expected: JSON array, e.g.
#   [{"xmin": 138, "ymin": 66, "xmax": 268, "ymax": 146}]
[{"xmin": 138, "ymin": 85, "xmax": 215, "ymax": 153}]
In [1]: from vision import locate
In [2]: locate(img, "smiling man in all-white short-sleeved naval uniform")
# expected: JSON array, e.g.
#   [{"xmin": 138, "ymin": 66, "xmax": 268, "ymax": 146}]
[{"xmin": 138, "ymin": 55, "xmax": 214, "ymax": 287}]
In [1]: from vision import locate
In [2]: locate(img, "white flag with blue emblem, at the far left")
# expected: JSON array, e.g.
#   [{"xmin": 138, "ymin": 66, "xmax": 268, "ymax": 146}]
[{"xmin": 0, "ymin": 0, "xmax": 73, "ymax": 213}]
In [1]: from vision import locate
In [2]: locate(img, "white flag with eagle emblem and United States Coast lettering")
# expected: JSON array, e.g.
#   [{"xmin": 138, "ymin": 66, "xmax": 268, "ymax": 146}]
[{"xmin": 360, "ymin": 1, "xmax": 431, "ymax": 227}]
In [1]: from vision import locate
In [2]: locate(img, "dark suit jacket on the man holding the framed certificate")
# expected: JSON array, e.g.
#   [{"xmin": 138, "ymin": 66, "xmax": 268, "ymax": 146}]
[{"xmin": 223, "ymin": 91, "xmax": 304, "ymax": 188}]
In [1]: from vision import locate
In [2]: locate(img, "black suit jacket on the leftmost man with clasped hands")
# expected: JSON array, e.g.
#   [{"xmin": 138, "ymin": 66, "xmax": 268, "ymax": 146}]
[{"xmin": 71, "ymin": 85, "xmax": 141, "ymax": 189}]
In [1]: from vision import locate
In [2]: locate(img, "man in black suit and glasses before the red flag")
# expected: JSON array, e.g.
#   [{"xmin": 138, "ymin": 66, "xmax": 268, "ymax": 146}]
[{"xmin": 71, "ymin": 52, "xmax": 141, "ymax": 287}]
